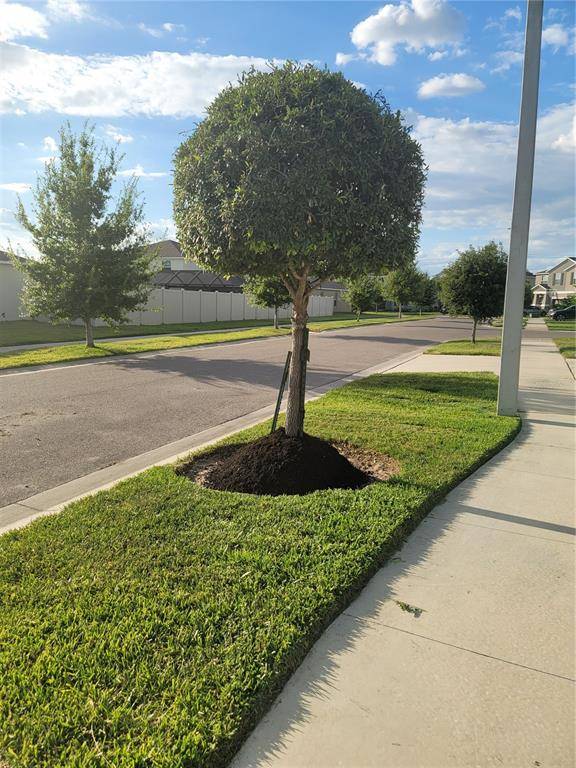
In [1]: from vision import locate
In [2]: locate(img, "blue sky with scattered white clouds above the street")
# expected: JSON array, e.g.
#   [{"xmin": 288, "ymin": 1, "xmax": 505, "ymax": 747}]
[{"xmin": 0, "ymin": 0, "xmax": 576, "ymax": 274}]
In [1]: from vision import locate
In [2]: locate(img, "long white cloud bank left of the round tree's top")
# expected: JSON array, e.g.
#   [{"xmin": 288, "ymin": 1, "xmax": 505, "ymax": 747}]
[{"xmin": 0, "ymin": 44, "xmax": 279, "ymax": 117}]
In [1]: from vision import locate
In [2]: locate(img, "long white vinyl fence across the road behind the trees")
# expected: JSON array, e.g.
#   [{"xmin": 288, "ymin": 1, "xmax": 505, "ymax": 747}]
[{"xmin": 86, "ymin": 288, "xmax": 334, "ymax": 325}]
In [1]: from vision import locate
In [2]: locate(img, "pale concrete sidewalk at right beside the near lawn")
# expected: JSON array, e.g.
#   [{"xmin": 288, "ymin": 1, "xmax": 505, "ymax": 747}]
[{"xmin": 232, "ymin": 326, "xmax": 575, "ymax": 768}]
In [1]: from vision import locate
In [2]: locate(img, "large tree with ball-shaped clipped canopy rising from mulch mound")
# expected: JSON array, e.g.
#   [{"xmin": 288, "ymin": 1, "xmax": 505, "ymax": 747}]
[{"xmin": 174, "ymin": 62, "xmax": 425, "ymax": 437}]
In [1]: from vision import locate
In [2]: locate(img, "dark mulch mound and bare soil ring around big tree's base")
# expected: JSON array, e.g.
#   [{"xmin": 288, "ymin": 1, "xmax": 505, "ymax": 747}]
[{"xmin": 179, "ymin": 428, "xmax": 399, "ymax": 496}]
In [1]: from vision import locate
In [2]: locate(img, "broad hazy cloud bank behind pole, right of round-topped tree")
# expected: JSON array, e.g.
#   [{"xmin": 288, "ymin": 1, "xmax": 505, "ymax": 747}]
[{"xmin": 408, "ymin": 104, "xmax": 575, "ymax": 269}]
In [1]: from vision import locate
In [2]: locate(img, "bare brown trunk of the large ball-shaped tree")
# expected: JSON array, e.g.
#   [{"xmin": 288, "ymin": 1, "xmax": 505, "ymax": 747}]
[{"xmin": 285, "ymin": 278, "xmax": 308, "ymax": 437}]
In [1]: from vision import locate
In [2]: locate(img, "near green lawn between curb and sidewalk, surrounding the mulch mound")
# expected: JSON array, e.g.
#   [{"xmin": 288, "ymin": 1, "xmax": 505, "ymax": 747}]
[{"xmin": 0, "ymin": 373, "xmax": 520, "ymax": 768}]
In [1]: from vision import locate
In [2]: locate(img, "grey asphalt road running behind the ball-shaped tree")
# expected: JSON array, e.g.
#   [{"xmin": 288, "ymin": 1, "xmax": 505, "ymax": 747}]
[{"xmin": 0, "ymin": 318, "xmax": 498, "ymax": 506}]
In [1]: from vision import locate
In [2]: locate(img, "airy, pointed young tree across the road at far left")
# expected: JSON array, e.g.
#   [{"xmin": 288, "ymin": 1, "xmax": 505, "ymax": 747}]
[{"xmin": 15, "ymin": 125, "xmax": 153, "ymax": 347}]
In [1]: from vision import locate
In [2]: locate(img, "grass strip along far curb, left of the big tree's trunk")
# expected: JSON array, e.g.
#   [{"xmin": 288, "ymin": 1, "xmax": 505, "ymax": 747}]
[{"xmin": 0, "ymin": 327, "xmax": 290, "ymax": 369}]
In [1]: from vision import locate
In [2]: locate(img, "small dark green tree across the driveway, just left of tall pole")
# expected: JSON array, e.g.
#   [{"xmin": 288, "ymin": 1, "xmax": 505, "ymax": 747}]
[{"xmin": 440, "ymin": 241, "xmax": 508, "ymax": 343}]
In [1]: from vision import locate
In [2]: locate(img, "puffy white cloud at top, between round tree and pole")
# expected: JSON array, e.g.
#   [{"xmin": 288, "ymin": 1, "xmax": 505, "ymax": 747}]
[{"xmin": 350, "ymin": 0, "xmax": 465, "ymax": 66}]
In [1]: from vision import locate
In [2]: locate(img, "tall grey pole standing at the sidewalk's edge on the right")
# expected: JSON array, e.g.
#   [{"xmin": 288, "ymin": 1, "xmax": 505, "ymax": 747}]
[{"xmin": 498, "ymin": 0, "xmax": 544, "ymax": 416}]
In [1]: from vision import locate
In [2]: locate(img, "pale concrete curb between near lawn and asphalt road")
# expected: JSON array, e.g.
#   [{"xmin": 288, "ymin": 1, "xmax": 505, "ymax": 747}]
[{"xmin": 0, "ymin": 345, "xmax": 424, "ymax": 535}]
